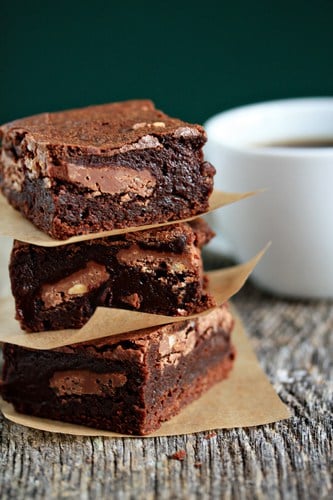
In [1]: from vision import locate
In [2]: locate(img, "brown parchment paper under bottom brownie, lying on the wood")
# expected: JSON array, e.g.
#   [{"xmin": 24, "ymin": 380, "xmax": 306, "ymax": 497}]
[{"xmin": 0, "ymin": 311, "xmax": 290, "ymax": 437}]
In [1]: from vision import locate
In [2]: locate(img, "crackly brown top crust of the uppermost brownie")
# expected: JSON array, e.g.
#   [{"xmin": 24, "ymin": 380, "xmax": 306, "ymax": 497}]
[{"xmin": 0, "ymin": 100, "xmax": 206, "ymax": 153}]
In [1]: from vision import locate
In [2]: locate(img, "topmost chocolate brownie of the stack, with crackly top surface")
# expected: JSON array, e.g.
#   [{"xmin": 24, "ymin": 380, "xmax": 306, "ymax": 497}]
[{"xmin": 0, "ymin": 100, "xmax": 215, "ymax": 239}]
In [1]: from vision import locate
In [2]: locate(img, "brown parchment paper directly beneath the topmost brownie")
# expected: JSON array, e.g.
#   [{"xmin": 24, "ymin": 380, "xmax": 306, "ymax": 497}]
[{"xmin": 0, "ymin": 190, "xmax": 261, "ymax": 247}]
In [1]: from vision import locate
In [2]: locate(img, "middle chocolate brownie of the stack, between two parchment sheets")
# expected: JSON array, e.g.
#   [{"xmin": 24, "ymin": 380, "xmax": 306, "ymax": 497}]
[{"xmin": 9, "ymin": 219, "xmax": 215, "ymax": 332}]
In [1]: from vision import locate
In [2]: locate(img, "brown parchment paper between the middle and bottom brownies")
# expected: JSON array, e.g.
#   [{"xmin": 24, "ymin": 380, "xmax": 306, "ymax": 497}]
[{"xmin": 0, "ymin": 247, "xmax": 267, "ymax": 349}]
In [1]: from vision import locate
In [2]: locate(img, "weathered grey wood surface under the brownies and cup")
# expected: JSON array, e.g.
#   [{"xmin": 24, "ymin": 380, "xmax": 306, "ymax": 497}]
[{"xmin": 0, "ymin": 285, "xmax": 333, "ymax": 500}]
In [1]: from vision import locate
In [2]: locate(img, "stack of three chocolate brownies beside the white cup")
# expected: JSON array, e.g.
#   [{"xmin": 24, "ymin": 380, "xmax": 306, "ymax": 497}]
[{"xmin": 0, "ymin": 100, "xmax": 234, "ymax": 435}]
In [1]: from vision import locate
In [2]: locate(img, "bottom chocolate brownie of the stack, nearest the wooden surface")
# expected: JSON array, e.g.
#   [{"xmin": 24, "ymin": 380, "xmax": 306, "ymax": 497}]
[{"xmin": 0, "ymin": 305, "xmax": 235, "ymax": 435}]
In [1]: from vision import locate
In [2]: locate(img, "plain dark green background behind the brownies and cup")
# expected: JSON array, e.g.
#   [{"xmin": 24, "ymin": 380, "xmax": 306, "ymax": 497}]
[{"xmin": 0, "ymin": 0, "xmax": 333, "ymax": 122}]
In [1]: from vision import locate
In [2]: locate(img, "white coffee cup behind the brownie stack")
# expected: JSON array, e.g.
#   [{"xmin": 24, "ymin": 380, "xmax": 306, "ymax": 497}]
[{"xmin": 205, "ymin": 98, "xmax": 333, "ymax": 298}]
